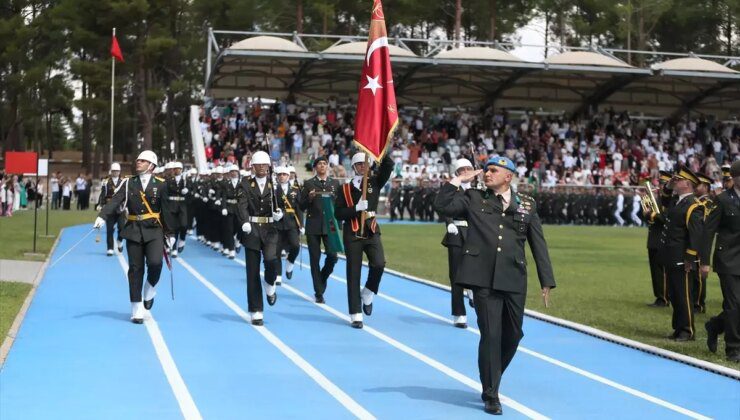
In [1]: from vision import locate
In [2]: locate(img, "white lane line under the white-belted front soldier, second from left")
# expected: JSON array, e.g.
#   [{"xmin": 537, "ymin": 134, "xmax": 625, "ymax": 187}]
[{"xmin": 175, "ymin": 257, "xmax": 375, "ymax": 419}]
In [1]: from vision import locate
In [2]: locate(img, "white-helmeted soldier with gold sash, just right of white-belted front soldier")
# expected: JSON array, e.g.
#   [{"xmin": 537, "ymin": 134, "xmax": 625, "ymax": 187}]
[{"xmin": 275, "ymin": 167, "xmax": 304, "ymax": 285}]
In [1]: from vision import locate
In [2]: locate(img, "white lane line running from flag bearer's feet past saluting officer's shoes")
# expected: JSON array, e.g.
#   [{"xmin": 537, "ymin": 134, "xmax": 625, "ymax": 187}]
[{"xmin": 233, "ymin": 258, "xmax": 548, "ymax": 420}]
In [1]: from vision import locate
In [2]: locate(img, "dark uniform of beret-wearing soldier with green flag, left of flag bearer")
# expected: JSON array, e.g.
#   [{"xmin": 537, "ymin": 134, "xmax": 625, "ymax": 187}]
[{"xmin": 300, "ymin": 176, "xmax": 339, "ymax": 299}]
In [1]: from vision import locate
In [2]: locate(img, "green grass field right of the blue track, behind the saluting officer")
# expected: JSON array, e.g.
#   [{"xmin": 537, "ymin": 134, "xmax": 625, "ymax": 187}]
[{"xmin": 382, "ymin": 223, "xmax": 738, "ymax": 368}]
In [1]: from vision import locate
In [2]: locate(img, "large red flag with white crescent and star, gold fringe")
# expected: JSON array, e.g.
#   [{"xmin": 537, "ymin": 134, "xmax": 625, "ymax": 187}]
[{"xmin": 355, "ymin": 0, "xmax": 398, "ymax": 162}]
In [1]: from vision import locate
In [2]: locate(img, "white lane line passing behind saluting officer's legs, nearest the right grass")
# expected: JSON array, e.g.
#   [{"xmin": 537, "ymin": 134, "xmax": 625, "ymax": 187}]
[{"xmin": 300, "ymin": 263, "xmax": 709, "ymax": 420}]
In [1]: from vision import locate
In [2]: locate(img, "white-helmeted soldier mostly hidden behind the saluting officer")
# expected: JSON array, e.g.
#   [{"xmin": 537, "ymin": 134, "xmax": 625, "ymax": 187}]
[{"xmin": 440, "ymin": 158, "xmax": 473, "ymax": 328}]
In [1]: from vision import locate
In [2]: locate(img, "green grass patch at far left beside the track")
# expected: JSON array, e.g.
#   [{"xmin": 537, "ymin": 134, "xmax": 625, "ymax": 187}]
[{"xmin": 0, "ymin": 209, "xmax": 97, "ymax": 261}]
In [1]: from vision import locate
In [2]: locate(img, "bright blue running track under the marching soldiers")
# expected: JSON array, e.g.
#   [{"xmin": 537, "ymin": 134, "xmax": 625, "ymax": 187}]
[{"xmin": 0, "ymin": 226, "xmax": 740, "ymax": 420}]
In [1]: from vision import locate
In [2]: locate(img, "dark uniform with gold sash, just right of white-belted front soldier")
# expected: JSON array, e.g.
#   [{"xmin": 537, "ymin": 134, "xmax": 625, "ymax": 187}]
[{"xmin": 275, "ymin": 182, "xmax": 303, "ymax": 275}]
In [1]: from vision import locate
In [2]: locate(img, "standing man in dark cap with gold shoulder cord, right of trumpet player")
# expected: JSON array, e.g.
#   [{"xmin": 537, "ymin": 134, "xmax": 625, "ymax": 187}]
[{"xmin": 654, "ymin": 167, "xmax": 706, "ymax": 341}]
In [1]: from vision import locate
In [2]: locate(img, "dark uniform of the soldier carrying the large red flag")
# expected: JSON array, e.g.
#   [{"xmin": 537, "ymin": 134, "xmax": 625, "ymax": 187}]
[{"xmin": 335, "ymin": 156, "xmax": 394, "ymax": 314}]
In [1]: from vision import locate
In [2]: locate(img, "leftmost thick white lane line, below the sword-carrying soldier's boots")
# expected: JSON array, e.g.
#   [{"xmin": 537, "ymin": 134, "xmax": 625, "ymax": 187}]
[{"xmin": 112, "ymin": 253, "xmax": 203, "ymax": 420}]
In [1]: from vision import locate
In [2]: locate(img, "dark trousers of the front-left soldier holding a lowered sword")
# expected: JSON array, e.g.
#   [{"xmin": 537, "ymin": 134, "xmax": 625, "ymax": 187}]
[{"xmin": 126, "ymin": 236, "xmax": 164, "ymax": 302}]
